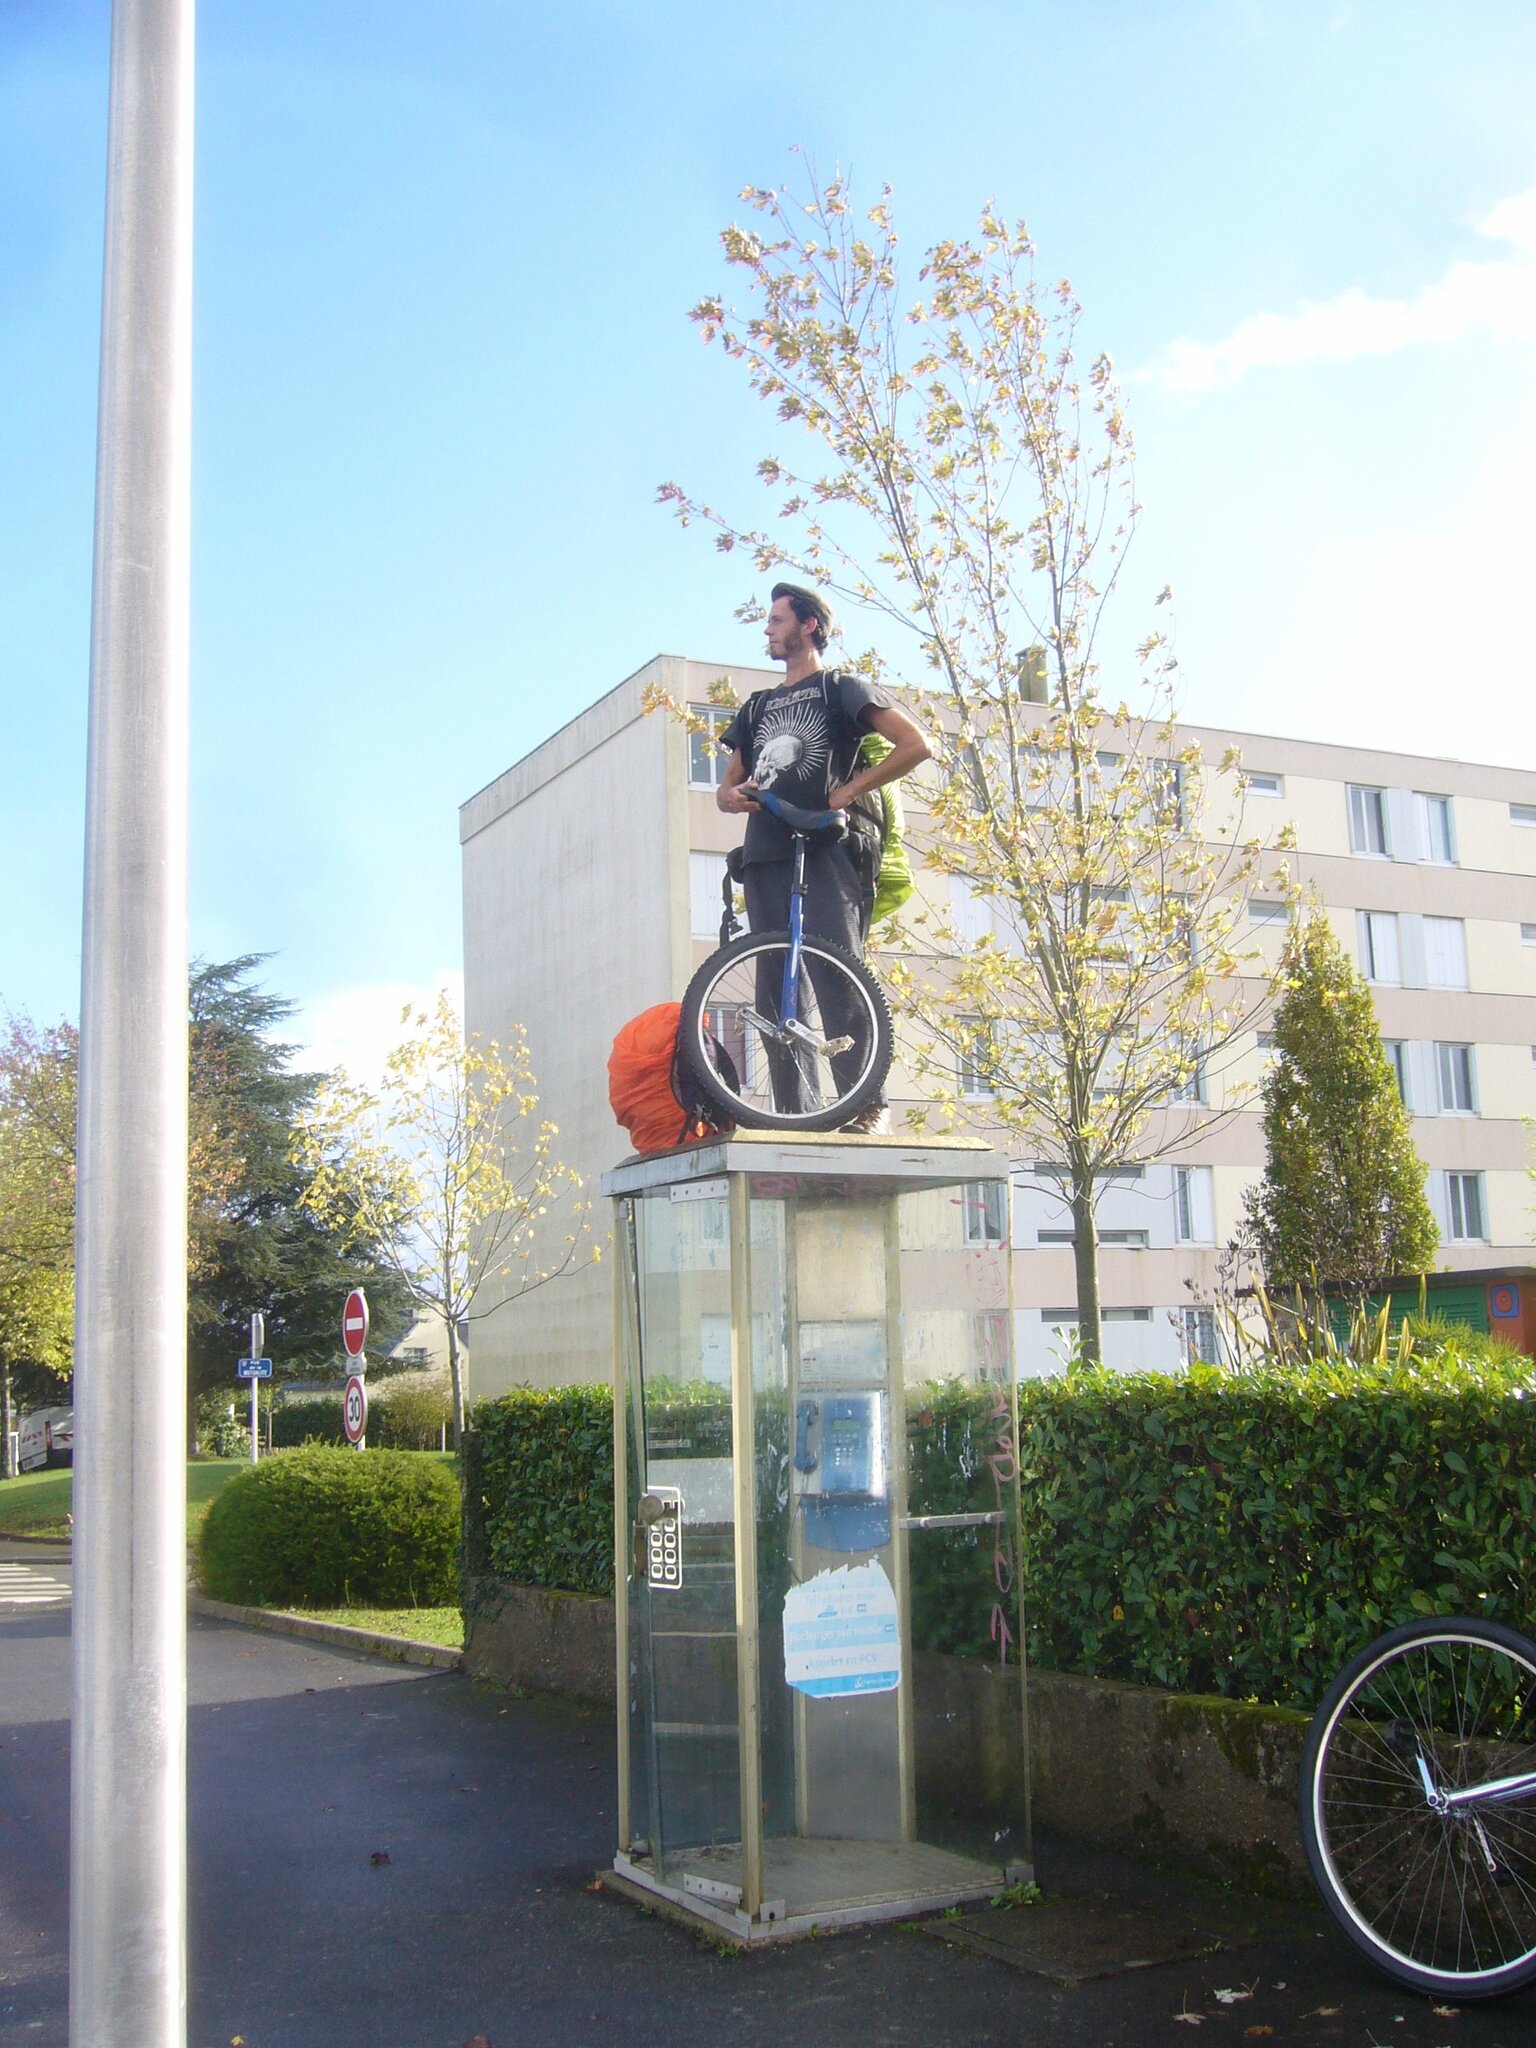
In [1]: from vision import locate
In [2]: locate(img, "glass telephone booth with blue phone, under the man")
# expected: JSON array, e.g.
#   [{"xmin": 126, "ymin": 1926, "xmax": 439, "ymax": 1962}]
[{"xmin": 604, "ymin": 1133, "xmax": 1030, "ymax": 1942}]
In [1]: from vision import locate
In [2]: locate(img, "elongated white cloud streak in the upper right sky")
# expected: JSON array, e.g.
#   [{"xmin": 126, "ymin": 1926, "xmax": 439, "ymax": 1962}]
[{"xmin": 1128, "ymin": 188, "xmax": 1536, "ymax": 391}]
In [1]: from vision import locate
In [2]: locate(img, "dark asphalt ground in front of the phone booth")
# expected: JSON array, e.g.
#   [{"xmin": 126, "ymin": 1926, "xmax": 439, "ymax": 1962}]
[{"xmin": 0, "ymin": 1544, "xmax": 1536, "ymax": 2048}]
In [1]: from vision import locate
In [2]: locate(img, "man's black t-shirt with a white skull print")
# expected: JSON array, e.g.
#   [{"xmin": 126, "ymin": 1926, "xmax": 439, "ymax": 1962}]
[{"xmin": 721, "ymin": 668, "xmax": 891, "ymax": 862}]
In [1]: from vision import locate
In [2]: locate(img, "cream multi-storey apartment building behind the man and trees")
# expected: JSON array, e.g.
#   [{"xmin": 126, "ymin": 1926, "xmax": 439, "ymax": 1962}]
[{"xmin": 459, "ymin": 655, "xmax": 1536, "ymax": 1397}]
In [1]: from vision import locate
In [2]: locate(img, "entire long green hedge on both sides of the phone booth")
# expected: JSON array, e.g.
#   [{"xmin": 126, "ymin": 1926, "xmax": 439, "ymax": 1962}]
[{"xmin": 471, "ymin": 1354, "xmax": 1536, "ymax": 1706}]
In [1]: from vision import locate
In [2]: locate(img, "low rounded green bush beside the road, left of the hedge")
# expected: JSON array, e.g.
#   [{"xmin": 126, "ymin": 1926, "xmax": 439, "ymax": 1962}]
[{"xmin": 199, "ymin": 1444, "xmax": 459, "ymax": 1608}]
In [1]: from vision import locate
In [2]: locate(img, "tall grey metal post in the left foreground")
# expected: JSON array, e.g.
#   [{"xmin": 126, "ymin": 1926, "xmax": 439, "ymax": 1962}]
[{"xmin": 70, "ymin": 0, "xmax": 193, "ymax": 2048}]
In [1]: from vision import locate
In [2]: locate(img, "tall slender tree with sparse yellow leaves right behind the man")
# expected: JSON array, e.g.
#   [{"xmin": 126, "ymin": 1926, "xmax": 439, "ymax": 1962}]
[{"xmin": 659, "ymin": 178, "xmax": 1288, "ymax": 1362}]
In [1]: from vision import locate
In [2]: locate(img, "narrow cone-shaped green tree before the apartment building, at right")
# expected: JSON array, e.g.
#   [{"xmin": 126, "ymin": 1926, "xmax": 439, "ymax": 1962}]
[{"xmin": 1249, "ymin": 911, "xmax": 1440, "ymax": 1296}]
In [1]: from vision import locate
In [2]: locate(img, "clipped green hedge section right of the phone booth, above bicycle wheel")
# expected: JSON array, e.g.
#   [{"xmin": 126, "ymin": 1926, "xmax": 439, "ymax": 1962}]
[{"xmin": 1020, "ymin": 1352, "xmax": 1536, "ymax": 1704}]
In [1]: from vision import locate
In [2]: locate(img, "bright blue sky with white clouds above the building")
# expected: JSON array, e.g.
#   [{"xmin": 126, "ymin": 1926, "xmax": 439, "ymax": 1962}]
[{"xmin": 0, "ymin": 0, "xmax": 1536, "ymax": 1059}]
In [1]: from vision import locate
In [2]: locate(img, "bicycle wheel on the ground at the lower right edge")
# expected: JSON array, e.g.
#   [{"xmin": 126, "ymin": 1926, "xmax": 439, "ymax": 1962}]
[{"xmin": 1300, "ymin": 1620, "xmax": 1536, "ymax": 1999}]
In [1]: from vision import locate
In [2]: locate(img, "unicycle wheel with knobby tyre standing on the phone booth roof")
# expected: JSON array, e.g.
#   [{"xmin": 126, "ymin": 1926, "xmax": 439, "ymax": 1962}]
[{"xmin": 678, "ymin": 932, "xmax": 893, "ymax": 1130}]
